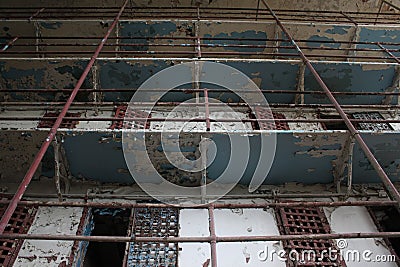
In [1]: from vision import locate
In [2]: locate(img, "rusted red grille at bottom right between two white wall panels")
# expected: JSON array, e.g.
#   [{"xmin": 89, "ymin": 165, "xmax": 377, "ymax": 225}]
[{"xmin": 277, "ymin": 207, "xmax": 346, "ymax": 266}]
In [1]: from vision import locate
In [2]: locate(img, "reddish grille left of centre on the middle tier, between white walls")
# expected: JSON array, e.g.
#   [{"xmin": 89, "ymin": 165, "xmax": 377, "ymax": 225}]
[{"xmin": 110, "ymin": 105, "xmax": 151, "ymax": 130}]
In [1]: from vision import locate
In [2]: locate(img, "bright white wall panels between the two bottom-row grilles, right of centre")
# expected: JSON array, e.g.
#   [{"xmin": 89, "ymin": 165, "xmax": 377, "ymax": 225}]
[{"xmin": 178, "ymin": 209, "xmax": 285, "ymax": 267}]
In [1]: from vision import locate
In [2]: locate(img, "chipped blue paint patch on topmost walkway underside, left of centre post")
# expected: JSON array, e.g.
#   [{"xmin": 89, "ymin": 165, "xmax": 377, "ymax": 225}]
[{"xmin": 120, "ymin": 21, "xmax": 179, "ymax": 51}]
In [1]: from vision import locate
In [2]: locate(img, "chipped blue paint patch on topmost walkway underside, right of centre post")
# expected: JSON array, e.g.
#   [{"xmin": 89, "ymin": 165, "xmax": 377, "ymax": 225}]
[{"xmin": 203, "ymin": 30, "xmax": 267, "ymax": 52}]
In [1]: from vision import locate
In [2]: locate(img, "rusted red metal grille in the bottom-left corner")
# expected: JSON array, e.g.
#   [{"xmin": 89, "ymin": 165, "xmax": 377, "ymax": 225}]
[{"xmin": 0, "ymin": 206, "xmax": 37, "ymax": 266}]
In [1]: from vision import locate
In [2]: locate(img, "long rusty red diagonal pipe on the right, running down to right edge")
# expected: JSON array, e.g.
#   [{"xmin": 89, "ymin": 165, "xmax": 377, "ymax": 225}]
[{"xmin": 262, "ymin": 0, "xmax": 400, "ymax": 205}]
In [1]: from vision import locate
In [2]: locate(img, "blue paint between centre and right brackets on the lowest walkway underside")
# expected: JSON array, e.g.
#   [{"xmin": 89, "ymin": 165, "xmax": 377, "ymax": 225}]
[{"xmin": 207, "ymin": 132, "xmax": 341, "ymax": 185}]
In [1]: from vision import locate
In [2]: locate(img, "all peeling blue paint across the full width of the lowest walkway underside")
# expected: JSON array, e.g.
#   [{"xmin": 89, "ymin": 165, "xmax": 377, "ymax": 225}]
[{"xmin": 34, "ymin": 131, "xmax": 400, "ymax": 184}]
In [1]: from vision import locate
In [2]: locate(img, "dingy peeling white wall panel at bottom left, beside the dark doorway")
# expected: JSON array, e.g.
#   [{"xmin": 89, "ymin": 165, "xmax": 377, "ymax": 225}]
[{"xmin": 14, "ymin": 207, "xmax": 83, "ymax": 267}]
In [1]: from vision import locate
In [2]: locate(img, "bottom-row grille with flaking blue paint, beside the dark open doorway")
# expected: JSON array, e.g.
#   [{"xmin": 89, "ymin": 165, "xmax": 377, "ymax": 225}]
[{"xmin": 127, "ymin": 208, "xmax": 179, "ymax": 267}]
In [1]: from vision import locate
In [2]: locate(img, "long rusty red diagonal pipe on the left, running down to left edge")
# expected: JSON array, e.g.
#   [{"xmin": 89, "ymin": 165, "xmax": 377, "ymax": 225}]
[{"xmin": 0, "ymin": 0, "xmax": 128, "ymax": 237}]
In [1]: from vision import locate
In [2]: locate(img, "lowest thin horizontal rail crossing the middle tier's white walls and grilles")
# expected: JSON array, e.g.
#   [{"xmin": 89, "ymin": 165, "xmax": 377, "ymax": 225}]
[{"xmin": 0, "ymin": 114, "xmax": 400, "ymax": 126}]
